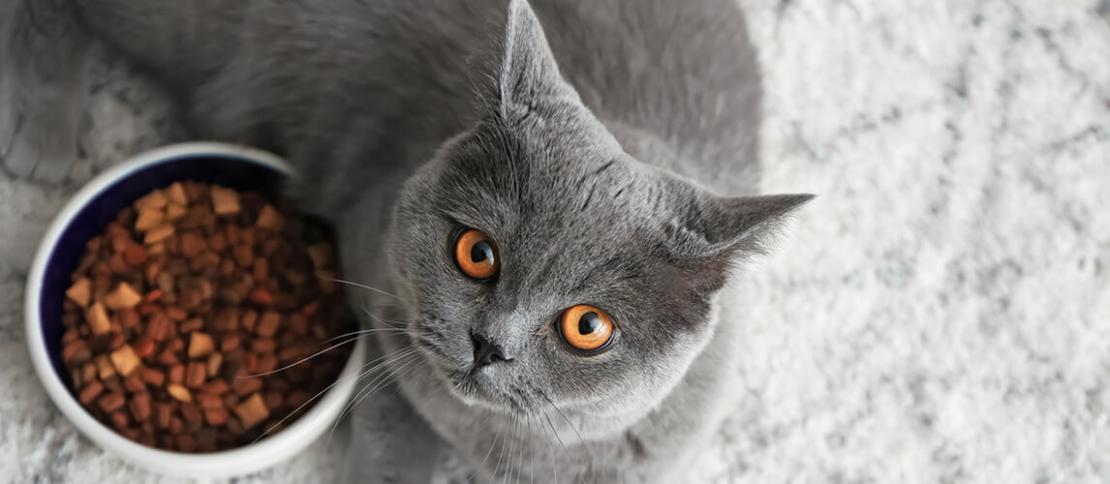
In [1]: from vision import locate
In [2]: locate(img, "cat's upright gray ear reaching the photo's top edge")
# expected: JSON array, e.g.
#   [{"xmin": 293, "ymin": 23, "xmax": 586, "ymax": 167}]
[{"xmin": 497, "ymin": 0, "xmax": 578, "ymax": 121}]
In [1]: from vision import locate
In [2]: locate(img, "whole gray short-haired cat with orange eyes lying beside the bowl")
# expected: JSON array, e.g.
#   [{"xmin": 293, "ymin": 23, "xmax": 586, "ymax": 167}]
[{"xmin": 28, "ymin": 0, "xmax": 809, "ymax": 483}]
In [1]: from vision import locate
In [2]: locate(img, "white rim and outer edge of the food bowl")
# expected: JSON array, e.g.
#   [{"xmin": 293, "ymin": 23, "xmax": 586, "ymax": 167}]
[{"xmin": 23, "ymin": 142, "xmax": 366, "ymax": 478}]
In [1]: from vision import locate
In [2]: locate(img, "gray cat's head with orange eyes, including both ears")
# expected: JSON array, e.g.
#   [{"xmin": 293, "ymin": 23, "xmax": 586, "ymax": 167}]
[{"xmin": 387, "ymin": 1, "xmax": 809, "ymax": 435}]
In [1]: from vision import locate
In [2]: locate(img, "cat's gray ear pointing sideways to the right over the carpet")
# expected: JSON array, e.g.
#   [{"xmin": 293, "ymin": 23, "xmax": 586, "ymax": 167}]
[{"xmin": 669, "ymin": 193, "xmax": 814, "ymax": 290}]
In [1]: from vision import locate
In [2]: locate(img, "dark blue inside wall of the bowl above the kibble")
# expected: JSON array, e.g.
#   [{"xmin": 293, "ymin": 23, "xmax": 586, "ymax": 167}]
[{"xmin": 39, "ymin": 154, "xmax": 285, "ymax": 391}]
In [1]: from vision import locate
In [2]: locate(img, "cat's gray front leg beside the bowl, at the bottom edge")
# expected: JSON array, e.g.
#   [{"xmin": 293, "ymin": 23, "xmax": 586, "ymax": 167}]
[{"xmin": 341, "ymin": 370, "xmax": 441, "ymax": 484}]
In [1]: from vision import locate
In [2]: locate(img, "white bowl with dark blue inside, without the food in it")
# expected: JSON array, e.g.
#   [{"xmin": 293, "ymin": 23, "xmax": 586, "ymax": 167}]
[{"xmin": 24, "ymin": 142, "xmax": 365, "ymax": 478}]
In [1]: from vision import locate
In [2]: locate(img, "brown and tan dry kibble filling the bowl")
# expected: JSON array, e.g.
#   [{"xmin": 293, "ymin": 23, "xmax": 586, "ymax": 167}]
[{"xmin": 62, "ymin": 181, "xmax": 350, "ymax": 452}]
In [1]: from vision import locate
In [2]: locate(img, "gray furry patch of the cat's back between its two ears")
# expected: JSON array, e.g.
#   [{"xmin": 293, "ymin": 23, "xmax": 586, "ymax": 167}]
[{"xmin": 533, "ymin": 0, "xmax": 761, "ymax": 194}]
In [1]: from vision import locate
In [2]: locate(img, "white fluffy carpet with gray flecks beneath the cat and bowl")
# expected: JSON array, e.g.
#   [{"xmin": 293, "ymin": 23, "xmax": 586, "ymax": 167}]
[{"xmin": 0, "ymin": 0, "xmax": 1110, "ymax": 483}]
